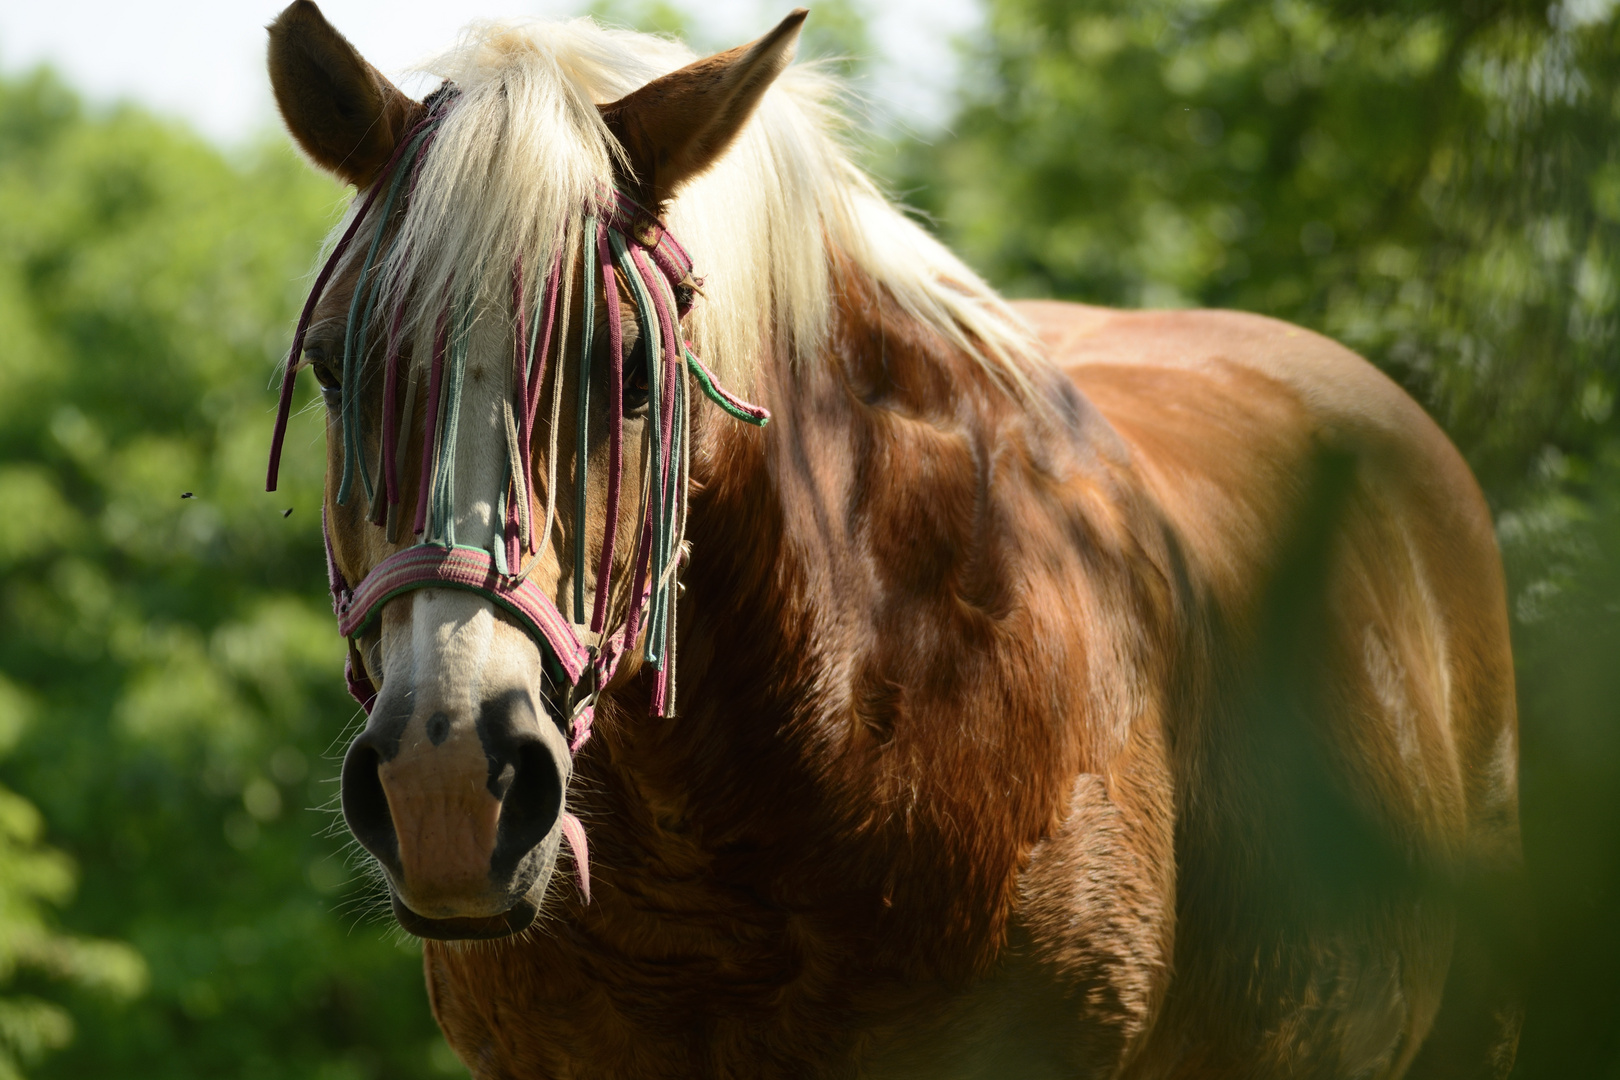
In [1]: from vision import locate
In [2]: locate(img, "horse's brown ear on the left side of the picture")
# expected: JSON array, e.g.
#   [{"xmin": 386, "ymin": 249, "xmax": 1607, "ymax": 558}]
[{"xmin": 269, "ymin": 0, "xmax": 423, "ymax": 188}]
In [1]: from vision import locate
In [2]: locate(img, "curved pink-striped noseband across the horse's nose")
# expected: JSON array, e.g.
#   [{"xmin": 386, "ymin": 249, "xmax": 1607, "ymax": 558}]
[{"xmin": 337, "ymin": 544, "xmax": 590, "ymax": 683}]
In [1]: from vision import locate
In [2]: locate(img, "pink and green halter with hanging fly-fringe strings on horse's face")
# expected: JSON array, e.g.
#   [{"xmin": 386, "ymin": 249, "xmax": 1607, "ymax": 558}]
[{"xmin": 266, "ymin": 83, "xmax": 770, "ymax": 744}]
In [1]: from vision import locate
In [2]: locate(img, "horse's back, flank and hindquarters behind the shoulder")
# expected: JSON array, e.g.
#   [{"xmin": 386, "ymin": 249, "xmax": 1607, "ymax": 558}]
[{"xmin": 1021, "ymin": 303, "xmax": 1520, "ymax": 1075}]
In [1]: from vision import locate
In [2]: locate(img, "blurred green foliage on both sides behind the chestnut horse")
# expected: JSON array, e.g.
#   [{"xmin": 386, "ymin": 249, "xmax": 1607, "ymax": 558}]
[{"xmin": 0, "ymin": 0, "xmax": 1620, "ymax": 1080}]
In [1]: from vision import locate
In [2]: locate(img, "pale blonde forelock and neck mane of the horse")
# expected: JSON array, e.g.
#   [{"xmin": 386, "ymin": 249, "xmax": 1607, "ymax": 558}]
[{"xmin": 351, "ymin": 18, "xmax": 1037, "ymax": 392}]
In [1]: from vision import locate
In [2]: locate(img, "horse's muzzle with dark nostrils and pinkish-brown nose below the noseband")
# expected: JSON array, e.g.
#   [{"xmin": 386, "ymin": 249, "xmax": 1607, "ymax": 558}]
[{"xmin": 342, "ymin": 683, "xmax": 572, "ymax": 939}]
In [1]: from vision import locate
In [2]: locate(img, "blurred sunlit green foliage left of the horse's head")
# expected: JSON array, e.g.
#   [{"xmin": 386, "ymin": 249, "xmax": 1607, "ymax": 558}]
[{"xmin": 0, "ymin": 73, "xmax": 465, "ymax": 1080}]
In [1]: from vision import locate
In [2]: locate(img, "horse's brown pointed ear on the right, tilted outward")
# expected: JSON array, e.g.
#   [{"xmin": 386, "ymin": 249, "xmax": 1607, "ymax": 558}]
[{"xmin": 599, "ymin": 8, "xmax": 807, "ymax": 207}]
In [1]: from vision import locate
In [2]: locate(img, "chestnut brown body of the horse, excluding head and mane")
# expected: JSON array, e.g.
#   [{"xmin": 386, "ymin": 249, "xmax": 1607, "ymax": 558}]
[{"xmin": 426, "ymin": 290, "xmax": 1516, "ymax": 1077}]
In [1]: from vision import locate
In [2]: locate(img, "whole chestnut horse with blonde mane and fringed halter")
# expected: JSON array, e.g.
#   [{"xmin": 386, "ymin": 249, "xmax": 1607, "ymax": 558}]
[{"xmin": 269, "ymin": 0, "xmax": 1521, "ymax": 1080}]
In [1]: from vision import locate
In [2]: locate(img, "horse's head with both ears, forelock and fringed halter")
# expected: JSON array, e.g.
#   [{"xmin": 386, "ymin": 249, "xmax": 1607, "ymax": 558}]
[{"xmin": 269, "ymin": 0, "xmax": 804, "ymax": 938}]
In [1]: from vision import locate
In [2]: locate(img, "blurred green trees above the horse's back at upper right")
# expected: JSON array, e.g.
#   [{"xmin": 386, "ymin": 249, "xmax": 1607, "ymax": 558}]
[{"xmin": 894, "ymin": 0, "xmax": 1620, "ymax": 500}]
